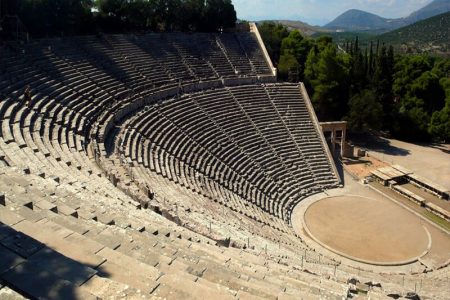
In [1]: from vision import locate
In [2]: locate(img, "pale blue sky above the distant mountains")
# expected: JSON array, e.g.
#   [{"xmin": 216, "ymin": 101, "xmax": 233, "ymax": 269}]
[{"xmin": 232, "ymin": 0, "xmax": 432, "ymax": 25}]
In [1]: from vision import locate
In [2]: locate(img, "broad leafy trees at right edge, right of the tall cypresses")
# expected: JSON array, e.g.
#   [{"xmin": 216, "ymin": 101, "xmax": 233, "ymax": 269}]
[{"xmin": 393, "ymin": 56, "xmax": 450, "ymax": 141}]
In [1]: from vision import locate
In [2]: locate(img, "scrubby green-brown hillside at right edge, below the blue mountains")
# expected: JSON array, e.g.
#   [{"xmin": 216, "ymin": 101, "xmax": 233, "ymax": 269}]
[{"xmin": 377, "ymin": 12, "xmax": 450, "ymax": 56}]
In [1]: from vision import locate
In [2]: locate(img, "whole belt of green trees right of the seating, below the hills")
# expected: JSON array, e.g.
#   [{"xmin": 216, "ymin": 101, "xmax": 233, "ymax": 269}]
[{"xmin": 260, "ymin": 23, "xmax": 450, "ymax": 141}]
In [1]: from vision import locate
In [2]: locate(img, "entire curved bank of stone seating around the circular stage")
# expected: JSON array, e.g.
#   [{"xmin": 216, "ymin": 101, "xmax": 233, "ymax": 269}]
[{"xmin": 0, "ymin": 33, "xmax": 440, "ymax": 299}]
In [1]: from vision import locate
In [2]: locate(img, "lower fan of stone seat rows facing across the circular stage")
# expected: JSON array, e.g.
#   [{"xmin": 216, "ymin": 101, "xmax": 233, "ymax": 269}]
[{"xmin": 111, "ymin": 84, "xmax": 338, "ymax": 224}]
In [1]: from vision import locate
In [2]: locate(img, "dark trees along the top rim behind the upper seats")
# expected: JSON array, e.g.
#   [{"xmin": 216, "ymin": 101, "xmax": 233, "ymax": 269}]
[{"xmin": 7, "ymin": 0, "xmax": 236, "ymax": 36}]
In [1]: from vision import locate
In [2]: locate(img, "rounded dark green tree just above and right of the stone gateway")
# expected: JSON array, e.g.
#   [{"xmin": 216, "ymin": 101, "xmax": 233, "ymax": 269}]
[{"xmin": 345, "ymin": 90, "xmax": 383, "ymax": 132}]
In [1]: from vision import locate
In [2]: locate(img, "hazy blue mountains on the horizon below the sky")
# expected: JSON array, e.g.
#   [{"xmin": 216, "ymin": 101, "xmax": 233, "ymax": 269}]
[{"xmin": 324, "ymin": 0, "xmax": 450, "ymax": 33}]
